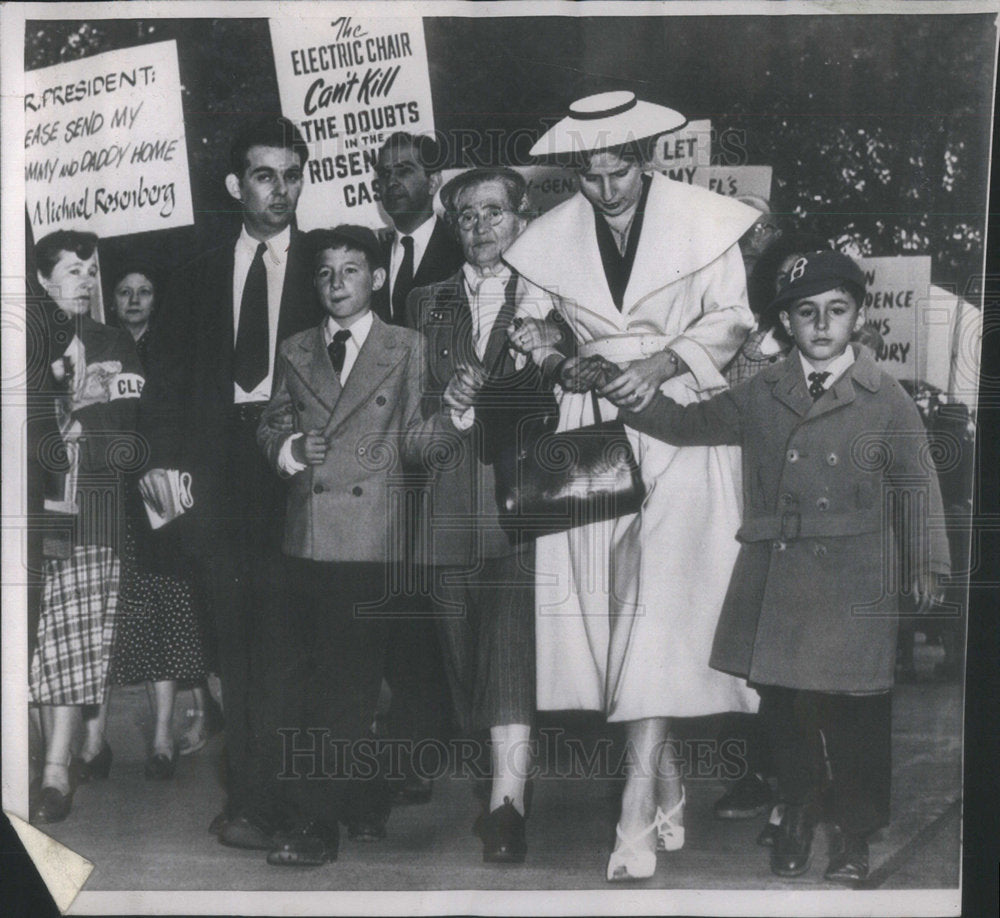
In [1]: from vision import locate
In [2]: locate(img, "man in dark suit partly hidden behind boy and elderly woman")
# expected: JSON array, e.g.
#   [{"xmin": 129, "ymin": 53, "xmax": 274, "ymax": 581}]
[{"xmin": 373, "ymin": 132, "xmax": 463, "ymax": 804}]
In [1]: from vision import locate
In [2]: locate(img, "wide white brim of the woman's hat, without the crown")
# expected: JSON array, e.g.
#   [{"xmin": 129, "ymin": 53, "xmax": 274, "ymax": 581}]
[{"xmin": 530, "ymin": 100, "xmax": 687, "ymax": 156}]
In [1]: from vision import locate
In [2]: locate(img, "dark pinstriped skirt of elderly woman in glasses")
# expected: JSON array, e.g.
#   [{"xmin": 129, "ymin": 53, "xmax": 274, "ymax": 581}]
[{"xmin": 434, "ymin": 544, "xmax": 535, "ymax": 733}]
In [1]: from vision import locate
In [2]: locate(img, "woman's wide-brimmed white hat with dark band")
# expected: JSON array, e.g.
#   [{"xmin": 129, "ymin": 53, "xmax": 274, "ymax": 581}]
[{"xmin": 531, "ymin": 90, "xmax": 687, "ymax": 156}]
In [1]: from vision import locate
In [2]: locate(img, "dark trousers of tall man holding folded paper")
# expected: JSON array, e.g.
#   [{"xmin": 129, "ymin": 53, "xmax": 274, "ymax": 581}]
[{"xmin": 179, "ymin": 411, "xmax": 290, "ymax": 822}]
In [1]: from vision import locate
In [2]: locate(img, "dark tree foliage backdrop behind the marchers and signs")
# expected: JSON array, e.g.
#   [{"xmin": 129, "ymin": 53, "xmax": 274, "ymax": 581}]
[{"xmin": 25, "ymin": 15, "xmax": 995, "ymax": 300}]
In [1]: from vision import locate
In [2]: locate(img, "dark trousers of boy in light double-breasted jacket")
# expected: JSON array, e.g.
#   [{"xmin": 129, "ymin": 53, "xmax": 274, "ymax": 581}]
[{"xmin": 271, "ymin": 558, "xmax": 393, "ymax": 826}]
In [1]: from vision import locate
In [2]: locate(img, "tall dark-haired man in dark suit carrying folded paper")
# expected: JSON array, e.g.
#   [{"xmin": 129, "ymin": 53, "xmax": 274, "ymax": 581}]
[{"xmin": 139, "ymin": 116, "xmax": 320, "ymax": 849}]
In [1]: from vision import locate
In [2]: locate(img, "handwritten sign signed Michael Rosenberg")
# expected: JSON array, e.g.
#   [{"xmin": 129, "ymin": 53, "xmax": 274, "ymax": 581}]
[{"xmin": 24, "ymin": 41, "xmax": 194, "ymax": 239}]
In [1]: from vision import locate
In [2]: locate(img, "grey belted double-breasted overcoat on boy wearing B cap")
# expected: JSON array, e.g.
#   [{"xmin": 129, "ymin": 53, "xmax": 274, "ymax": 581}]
[{"xmin": 621, "ymin": 347, "xmax": 948, "ymax": 692}]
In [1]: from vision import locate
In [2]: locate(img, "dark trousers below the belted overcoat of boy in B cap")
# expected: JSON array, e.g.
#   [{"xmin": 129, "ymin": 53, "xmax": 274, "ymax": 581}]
[{"xmin": 758, "ymin": 686, "xmax": 892, "ymax": 836}]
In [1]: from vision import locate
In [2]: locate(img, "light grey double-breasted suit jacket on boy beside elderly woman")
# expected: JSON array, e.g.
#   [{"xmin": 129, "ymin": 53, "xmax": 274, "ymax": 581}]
[{"xmin": 257, "ymin": 316, "xmax": 433, "ymax": 562}]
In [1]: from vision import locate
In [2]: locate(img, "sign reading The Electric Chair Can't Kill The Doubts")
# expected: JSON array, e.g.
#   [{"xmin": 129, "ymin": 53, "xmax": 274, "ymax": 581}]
[{"xmin": 270, "ymin": 15, "xmax": 434, "ymax": 229}]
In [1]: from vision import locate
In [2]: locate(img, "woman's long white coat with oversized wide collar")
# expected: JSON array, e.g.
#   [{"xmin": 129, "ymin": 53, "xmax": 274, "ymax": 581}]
[{"xmin": 504, "ymin": 175, "xmax": 757, "ymax": 721}]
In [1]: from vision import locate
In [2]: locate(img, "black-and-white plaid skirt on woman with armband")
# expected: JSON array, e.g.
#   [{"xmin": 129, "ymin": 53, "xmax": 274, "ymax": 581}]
[{"xmin": 28, "ymin": 545, "xmax": 119, "ymax": 705}]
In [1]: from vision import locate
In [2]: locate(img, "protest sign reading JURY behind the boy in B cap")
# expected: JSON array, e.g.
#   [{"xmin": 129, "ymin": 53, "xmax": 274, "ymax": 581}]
[{"xmin": 857, "ymin": 255, "xmax": 931, "ymax": 380}]
